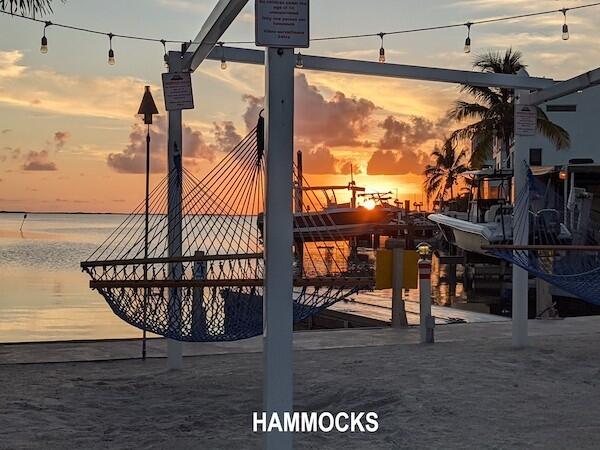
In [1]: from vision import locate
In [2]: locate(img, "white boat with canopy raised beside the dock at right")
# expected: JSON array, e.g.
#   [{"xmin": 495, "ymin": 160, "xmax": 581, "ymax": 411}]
[{"xmin": 428, "ymin": 169, "xmax": 571, "ymax": 256}]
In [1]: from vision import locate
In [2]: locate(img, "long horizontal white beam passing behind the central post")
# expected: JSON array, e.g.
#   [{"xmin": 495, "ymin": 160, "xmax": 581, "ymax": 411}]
[{"xmin": 206, "ymin": 46, "xmax": 554, "ymax": 90}]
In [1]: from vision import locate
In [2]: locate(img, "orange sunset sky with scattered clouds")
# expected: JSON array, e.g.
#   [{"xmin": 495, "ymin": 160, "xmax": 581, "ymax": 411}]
[{"xmin": 0, "ymin": 0, "xmax": 600, "ymax": 212}]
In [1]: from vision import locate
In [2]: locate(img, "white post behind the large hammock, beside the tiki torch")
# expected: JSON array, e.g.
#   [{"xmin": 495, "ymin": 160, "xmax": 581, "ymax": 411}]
[{"xmin": 167, "ymin": 52, "xmax": 183, "ymax": 370}]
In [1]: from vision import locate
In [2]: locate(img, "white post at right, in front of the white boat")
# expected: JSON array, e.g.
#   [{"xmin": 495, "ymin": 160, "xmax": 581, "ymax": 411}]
[{"xmin": 512, "ymin": 82, "xmax": 529, "ymax": 347}]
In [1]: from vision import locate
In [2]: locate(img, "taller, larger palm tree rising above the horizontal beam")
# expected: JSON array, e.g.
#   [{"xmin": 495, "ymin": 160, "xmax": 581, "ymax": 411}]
[{"xmin": 448, "ymin": 48, "xmax": 571, "ymax": 167}]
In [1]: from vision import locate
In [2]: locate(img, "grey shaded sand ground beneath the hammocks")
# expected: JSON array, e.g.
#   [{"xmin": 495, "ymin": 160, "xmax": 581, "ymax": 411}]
[{"xmin": 0, "ymin": 334, "xmax": 600, "ymax": 450}]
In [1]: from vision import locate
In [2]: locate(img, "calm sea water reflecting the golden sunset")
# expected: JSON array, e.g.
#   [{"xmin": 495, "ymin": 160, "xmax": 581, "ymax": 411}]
[{"xmin": 0, "ymin": 213, "xmax": 488, "ymax": 342}]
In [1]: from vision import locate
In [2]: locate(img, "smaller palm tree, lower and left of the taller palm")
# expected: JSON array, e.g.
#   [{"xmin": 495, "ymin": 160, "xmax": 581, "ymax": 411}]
[{"xmin": 423, "ymin": 139, "xmax": 468, "ymax": 206}]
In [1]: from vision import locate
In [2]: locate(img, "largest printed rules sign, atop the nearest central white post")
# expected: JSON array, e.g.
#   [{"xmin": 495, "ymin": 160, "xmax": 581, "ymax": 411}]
[{"xmin": 255, "ymin": 0, "xmax": 310, "ymax": 48}]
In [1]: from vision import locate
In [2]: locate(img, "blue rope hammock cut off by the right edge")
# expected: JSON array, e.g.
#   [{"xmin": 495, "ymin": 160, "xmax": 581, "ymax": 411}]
[{"xmin": 489, "ymin": 165, "xmax": 600, "ymax": 305}]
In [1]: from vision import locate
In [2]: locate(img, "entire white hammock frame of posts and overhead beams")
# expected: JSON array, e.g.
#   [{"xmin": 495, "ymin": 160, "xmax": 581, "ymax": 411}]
[{"xmin": 168, "ymin": 0, "xmax": 600, "ymax": 449}]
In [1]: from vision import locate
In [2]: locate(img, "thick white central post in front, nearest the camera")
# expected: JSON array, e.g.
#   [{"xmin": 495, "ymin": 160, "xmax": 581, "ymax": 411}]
[{"xmin": 263, "ymin": 48, "xmax": 294, "ymax": 450}]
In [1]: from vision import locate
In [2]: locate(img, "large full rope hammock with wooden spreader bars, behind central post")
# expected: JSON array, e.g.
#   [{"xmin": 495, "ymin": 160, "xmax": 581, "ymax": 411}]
[{"xmin": 81, "ymin": 118, "xmax": 373, "ymax": 342}]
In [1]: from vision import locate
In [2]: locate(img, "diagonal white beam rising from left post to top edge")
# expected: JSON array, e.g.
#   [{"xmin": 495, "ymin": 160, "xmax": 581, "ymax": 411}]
[{"xmin": 183, "ymin": 0, "xmax": 248, "ymax": 72}]
